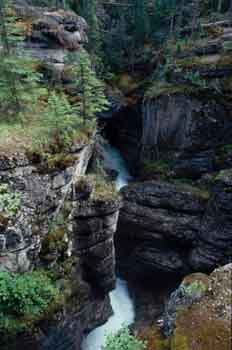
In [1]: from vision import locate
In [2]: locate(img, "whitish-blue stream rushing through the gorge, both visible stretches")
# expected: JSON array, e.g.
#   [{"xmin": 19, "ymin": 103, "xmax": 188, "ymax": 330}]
[{"xmin": 82, "ymin": 145, "xmax": 135, "ymax": 350}]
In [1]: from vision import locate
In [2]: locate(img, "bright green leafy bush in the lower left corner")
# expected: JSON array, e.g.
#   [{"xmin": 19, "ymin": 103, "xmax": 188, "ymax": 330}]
[{"xmin": 0, "ymin": 271, "xmax": 61, "ymax": 335}]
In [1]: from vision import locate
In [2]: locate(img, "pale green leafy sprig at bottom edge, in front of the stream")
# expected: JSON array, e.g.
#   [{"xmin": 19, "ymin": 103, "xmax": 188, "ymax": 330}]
[{"xmin": 103, "ymin": 327, "xmax": 145, "ymax": 350}]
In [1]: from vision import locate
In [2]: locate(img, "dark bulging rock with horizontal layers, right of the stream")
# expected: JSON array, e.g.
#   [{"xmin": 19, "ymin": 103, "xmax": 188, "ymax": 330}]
[{"xmin": 116, "ymin": 181, "xmax": 232, "ymax": 276}]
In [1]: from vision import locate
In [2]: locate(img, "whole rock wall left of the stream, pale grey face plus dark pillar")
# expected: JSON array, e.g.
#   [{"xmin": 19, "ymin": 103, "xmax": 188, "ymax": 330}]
[{"xmin": 0, "ymin": 143, "xmax": 121, "ymax": 350}]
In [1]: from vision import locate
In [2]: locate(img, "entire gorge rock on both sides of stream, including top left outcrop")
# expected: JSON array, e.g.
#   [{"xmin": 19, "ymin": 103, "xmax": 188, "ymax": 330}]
[{"xmin": 0, "ymin": 1, "xmax": 232, "ymax": 350}]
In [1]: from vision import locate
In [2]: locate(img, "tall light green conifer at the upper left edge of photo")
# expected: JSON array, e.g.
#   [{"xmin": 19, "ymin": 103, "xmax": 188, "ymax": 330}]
[{"xmin": 0, "ymin": 0, "xmax": 41, "ymax": 119}]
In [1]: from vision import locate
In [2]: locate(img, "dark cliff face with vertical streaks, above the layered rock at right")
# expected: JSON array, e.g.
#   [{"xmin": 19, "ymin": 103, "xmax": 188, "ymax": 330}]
[{"xmin": 141, "ymin": 93, "xmax": 232, "ymax": 178}]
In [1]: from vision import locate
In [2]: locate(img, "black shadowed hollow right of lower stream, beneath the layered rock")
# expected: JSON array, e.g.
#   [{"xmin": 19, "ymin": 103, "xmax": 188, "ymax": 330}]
[{"xmin": 115, "ymin": 232, "xmax": 181, "ymax": 330}]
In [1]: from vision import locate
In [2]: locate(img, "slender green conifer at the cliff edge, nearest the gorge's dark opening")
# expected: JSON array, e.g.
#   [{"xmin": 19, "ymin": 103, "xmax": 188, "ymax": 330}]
[{"xmin": 71, "ymin": 51, "xmax": 108, "ymax": 124}]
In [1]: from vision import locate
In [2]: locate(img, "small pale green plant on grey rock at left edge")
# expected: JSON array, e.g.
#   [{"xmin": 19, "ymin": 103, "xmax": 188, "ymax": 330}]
[{"xmin": 0, "ymin": 184, "xmax": 21, "ymax": 217}]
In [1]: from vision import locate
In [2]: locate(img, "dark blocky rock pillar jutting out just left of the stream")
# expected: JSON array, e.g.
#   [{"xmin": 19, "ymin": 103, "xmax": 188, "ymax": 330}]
[{"xmin": 72, "ymin": 200, "xmax": 121, "ymax": 293}]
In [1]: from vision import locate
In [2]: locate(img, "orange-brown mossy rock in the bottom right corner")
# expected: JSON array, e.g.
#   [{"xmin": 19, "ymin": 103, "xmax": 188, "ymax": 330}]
[{"xmin": 170, "ymin": 264, "xmax": 232, "ymax": 350}]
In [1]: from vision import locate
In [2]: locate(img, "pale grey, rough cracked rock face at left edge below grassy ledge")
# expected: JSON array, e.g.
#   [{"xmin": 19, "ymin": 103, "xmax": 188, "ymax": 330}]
[{"xmin": 0, "ymin": 145, "xmax": 93, "ymax": 272}]
